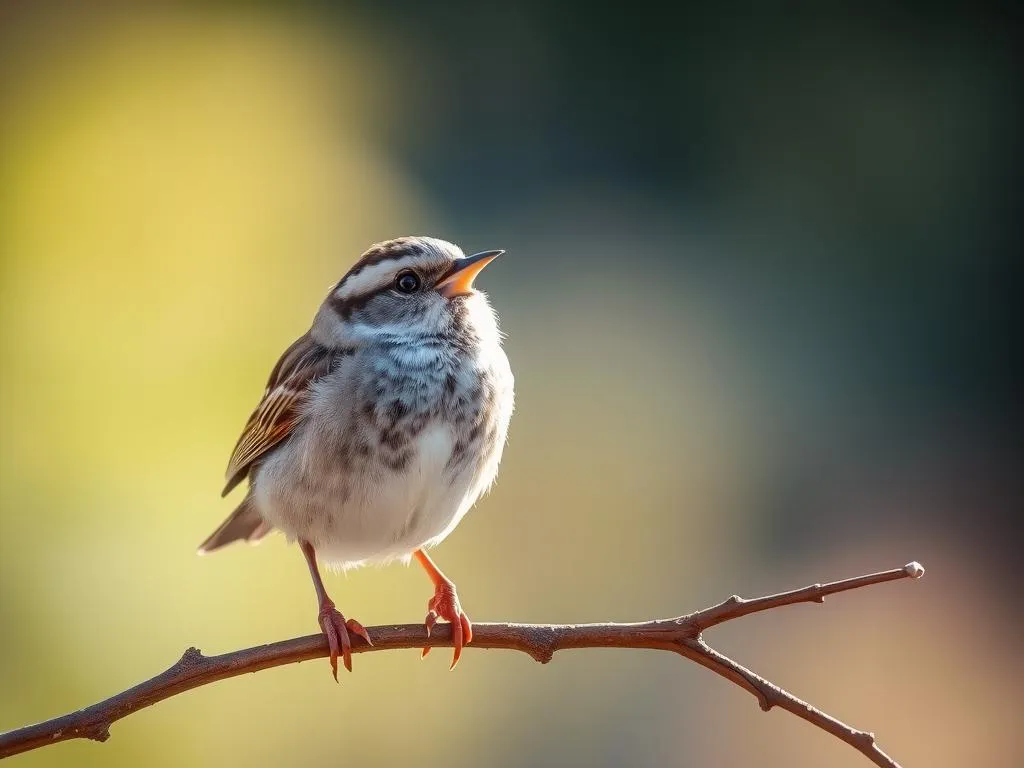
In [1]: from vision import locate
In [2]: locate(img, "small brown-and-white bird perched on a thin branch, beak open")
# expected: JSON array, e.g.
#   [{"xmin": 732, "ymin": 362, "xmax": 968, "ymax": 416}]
[{"xmin": 199, "ymin": 236, "xmax": 514, "ymax": 681}]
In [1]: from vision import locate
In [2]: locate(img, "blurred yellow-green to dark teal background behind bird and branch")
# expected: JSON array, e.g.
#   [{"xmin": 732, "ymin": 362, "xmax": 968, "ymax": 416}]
[{"xmin": 0, "ymin": 2, "xmax": 1024, "ymax": 768}]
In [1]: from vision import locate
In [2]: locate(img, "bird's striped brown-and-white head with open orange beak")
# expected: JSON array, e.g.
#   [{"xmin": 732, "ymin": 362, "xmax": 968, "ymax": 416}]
[{"xmin": 312, "ymin": 237, "xmax": 503, "ymax": 346}]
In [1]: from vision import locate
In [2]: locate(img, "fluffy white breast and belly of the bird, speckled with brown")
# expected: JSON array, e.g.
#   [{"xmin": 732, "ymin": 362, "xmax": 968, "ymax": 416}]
[{"xmin": 258, "ymin": 335, "xmax": 512, "ymax": 564}]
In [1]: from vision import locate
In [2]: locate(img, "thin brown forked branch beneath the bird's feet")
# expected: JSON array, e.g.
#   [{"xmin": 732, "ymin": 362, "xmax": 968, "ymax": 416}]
[{"xmin": 0, "ymin": 562, "xmax": 925, "ymax": 768}]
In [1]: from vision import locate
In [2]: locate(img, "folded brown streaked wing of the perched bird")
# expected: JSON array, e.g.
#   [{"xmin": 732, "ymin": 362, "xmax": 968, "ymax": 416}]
[{"xmin": 221, "ymin": 333, "xmax": 334, "ymax": 496}]
